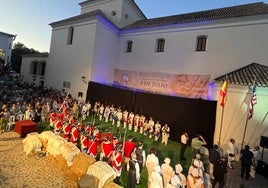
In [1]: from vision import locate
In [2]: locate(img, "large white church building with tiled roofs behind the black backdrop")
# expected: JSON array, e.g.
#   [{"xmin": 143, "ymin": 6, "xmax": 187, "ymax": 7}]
[{"xmin": 22, "ymin": 0, "xmax": 268, "ymax": 156}]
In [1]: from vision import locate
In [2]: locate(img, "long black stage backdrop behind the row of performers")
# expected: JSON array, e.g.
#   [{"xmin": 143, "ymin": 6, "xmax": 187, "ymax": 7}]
[{"xmin": 87, "ymin": 82, "xmax": 217, "ymax": 147}]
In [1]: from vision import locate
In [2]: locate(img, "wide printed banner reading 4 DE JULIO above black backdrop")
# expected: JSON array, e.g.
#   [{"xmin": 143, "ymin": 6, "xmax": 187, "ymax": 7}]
[{"xmin": 114, "ymin": 69, "xmax": 210, "ymax": 99}]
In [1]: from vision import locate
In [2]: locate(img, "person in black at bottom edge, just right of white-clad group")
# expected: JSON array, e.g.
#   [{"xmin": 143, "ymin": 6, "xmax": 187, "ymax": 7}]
[{"xmin": 212, "ymin": 160, "xmax": 227, "ymax": 188}]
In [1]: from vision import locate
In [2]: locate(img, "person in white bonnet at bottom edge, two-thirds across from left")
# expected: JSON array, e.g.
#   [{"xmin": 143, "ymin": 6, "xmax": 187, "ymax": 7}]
[{"xmin": 170, "ymin": 164, "xmax": 187, "ymax": 188}]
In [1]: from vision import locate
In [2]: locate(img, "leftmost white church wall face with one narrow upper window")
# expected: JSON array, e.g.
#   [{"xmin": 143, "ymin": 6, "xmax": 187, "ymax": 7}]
[{"xmin": 46, "ymin": 20, "xmax": 96, "ymax": 97}]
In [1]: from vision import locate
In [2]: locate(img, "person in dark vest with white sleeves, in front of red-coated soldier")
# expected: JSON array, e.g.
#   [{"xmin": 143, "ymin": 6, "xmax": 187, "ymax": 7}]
[{"xmin": 127, "ymin": 152, "xmax": 140, "ymax": 188}]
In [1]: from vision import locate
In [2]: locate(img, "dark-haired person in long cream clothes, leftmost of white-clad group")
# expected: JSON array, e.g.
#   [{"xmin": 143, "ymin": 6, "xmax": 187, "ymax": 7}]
[{"xmin": 146, "ymin": 147, "xmax": 159, "ymax": 187}]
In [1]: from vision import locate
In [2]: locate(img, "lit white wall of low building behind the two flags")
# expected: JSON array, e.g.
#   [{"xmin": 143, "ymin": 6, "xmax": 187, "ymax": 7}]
[{"xmin": 214, "ymin": 85, "xmax": 268, "ymax": 161}]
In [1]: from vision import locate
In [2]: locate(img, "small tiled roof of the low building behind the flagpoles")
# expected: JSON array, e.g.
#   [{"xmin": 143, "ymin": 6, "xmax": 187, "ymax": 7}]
[{"xmin": 215, "ymin": 63, "xmax": 268, "ymax": 87}]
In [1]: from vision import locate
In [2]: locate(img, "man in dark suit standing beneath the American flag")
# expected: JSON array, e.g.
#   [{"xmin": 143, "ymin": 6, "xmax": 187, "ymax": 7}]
[{"xmin": 240, "ymin": 145, "xmax": 253, "ymax": 180}]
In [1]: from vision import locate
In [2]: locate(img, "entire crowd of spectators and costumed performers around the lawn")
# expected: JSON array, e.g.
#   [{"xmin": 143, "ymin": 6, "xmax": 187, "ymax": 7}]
[{"xmin": 0, "ymin": 71, "xmax": 259, "ymax": 188}]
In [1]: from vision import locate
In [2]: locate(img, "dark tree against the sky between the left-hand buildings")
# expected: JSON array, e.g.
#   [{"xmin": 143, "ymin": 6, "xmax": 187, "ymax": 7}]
[{"xmin": 11, "ymin": 42, "xmax": 43, "ymax": 73}]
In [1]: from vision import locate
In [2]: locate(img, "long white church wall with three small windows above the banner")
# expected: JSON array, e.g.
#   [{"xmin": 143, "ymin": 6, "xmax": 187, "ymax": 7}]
[{"xmin": 117, "ymin": 15, "xmax": 268, "ymax": 79}]
